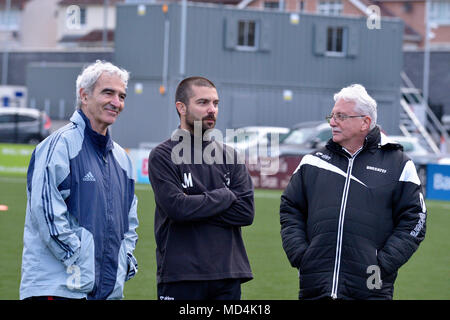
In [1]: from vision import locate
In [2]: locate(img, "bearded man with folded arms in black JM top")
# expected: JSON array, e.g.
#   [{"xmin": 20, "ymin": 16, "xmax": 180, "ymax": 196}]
[{"xmin": 148, "ymin": 77, "xmax": 254, "ymax": 300}]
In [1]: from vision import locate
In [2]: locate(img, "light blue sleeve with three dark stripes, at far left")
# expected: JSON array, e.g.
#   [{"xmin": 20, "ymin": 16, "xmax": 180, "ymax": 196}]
[{"xmin": 27, "ymin": 135, "xmax": 81, "ymax": 267}]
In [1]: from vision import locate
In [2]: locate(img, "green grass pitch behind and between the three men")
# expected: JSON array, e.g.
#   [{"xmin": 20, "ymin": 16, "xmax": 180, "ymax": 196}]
[{"xmin": 0, "ymin": 177, "xmax": 450, "ymax": 300}]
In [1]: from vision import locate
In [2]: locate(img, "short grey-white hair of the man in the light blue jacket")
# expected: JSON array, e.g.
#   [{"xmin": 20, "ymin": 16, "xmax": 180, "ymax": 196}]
[{"xmin": 76, "ymin": 60, "xmax": 130, "ymax": 109}]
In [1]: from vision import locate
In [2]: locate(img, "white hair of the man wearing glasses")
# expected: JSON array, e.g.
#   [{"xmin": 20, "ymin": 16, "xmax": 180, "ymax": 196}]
[{"xmin": 334, "ymin": 84, "xmax": 377, "ymax": 130}]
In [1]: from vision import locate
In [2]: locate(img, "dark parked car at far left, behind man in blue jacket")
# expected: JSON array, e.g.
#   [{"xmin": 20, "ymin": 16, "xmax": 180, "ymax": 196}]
[{"xmin": 0, "ymin": 107, "xmax": 51, "ymax": 144}]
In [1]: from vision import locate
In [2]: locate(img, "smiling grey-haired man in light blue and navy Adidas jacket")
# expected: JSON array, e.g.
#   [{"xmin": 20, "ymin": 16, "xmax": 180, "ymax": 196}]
[{"xmin": 20, "ymin": 61, "xmax": 138, "ymax": 300}]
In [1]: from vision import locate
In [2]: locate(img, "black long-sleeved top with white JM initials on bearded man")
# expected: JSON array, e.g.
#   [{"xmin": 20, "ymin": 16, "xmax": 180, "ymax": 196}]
[{"xmin": 148, "ymin": 129, "xmax": 254, "ymax": 283}]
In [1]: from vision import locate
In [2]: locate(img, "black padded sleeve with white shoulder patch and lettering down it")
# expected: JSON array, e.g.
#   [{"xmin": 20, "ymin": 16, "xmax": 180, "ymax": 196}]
[{"xmin": 378, "ymin": 160, "xmax": 427, "ymax": 277}]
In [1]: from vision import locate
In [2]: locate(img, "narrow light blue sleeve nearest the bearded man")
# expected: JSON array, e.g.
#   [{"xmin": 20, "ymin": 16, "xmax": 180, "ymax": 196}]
[{"xmin": 124, "ymin": 195, "xmax": 139, "ymax": 281}]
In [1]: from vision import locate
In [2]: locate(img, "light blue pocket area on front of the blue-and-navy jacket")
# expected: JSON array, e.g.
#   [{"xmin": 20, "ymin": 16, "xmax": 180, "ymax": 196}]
[{"xmin": 66, "ymin": 228, "xmax": 95, "ymax": 293}]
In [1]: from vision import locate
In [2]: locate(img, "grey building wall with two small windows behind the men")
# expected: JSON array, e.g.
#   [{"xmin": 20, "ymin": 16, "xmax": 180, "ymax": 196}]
[{"xmin": 113, "ymin": 4, "xmax": 403, "ymax": 147}]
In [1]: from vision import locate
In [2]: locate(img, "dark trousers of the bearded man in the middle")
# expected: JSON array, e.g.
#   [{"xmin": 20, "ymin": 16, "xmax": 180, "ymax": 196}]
[{"xmin": 158, "ymin": 279, "xmax": 241, "ymax": 300}]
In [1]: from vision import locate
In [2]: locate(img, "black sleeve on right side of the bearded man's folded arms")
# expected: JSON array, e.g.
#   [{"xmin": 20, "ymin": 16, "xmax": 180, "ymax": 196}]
[{"xmin": 210, "ymin": 164, "xmax": 255, "ymax": 227}]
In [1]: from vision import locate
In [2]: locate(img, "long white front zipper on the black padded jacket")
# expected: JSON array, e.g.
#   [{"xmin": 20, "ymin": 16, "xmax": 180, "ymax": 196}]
[{"xmin": 331, "ymin": 148, "xmax": 362, "ymax": 299}]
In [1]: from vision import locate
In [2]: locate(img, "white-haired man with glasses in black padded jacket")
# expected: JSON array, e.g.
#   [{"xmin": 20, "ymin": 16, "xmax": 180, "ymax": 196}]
[{"xmin": 280, "ymin": 84, "xmax": 427, "ymax": 299}]
